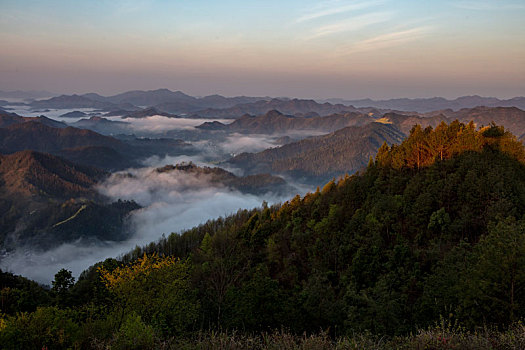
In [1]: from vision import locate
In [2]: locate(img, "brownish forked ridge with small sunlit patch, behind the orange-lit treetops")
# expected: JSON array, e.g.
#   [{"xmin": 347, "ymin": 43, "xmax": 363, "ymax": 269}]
[{"xmin": 223, "ymin": 107, "xmax": 525, "ymax": 184}]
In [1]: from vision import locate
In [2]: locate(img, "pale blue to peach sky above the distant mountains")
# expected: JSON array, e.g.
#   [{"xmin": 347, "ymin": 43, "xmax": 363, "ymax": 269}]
[{"xmin": 0, "ymin": 0, "xmax": 525, "ymax": 99}]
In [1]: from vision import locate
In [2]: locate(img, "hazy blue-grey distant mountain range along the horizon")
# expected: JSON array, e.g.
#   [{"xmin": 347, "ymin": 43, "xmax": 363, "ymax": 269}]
[{"xmin": 10, "ymin": 89, "xmax": 525, "ymax": 119}]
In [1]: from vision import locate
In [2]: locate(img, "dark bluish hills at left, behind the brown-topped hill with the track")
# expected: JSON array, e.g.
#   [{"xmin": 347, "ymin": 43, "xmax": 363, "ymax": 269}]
[{"xmin": 0, "ymin": 115, "xmax": 194, "ymax": 170}]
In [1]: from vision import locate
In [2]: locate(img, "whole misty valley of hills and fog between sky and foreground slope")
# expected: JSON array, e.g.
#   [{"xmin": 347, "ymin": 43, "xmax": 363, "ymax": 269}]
[{"xmin": 0, "ymin": 89, "xmax": 525, "ymax": 283}]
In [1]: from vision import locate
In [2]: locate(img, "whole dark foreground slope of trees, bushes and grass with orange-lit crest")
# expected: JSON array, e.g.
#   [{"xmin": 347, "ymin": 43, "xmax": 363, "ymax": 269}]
[{"xmin": 0, "ymin": 122, "xmax": 525, "ymax": 349}]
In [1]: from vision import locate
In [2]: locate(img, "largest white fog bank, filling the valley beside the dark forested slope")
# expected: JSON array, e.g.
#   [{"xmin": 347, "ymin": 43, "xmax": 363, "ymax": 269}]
[{"xmin": 1, "ymin": 157, "xmax": 304, "ymax": 284}]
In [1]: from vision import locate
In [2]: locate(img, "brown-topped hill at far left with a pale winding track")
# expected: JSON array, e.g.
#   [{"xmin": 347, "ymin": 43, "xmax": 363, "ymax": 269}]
[{"xmin": 0, "ymin": 151, "xmax": 138, "ymax": 249}]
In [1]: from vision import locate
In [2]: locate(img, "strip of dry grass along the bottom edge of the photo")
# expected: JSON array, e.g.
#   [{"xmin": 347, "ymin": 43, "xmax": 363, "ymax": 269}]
[{"xmin": 91, "ymin": 322, "xmax": 525, "ymax": 350}]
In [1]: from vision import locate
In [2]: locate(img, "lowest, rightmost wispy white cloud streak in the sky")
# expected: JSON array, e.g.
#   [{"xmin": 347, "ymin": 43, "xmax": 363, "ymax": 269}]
[{"xmin": 341, "ymin": 26, "xmax": 431, "ymax": 54}]
